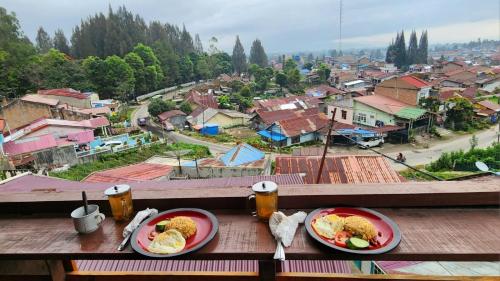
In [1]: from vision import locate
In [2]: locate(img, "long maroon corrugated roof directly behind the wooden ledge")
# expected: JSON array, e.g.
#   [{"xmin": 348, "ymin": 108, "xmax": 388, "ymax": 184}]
[{"xmin": 0, "ymin": 174, "xmax": 304, "ymax": 192}]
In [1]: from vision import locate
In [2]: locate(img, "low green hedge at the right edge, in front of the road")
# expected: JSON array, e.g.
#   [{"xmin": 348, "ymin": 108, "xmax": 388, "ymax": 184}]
[{"xmin": 426, "ymin": 143, "xmax": 500, "ymax": 172}]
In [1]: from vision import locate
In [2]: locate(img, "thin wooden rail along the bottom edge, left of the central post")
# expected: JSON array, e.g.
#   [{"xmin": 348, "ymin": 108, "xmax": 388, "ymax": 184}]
[{"xmin": 66, "ymin": 271, "xmax": 258, "ymax": 281}]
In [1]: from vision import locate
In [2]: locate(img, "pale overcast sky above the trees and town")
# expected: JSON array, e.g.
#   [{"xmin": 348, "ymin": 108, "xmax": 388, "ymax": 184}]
[{"xmin": 0, "ymin": 0, "xmax": 500, "ymax": 53}]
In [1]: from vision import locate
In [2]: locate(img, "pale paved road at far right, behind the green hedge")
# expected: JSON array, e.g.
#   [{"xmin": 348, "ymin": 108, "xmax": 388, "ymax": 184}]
[{"xmin": 389, "ymin": 126, "xmax": 498, "ymax": 170}]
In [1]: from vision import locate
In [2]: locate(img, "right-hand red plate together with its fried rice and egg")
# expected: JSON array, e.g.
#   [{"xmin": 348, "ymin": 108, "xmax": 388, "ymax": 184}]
[{"xmin": 305, "ymin": 207, "xmax": 401, "ymax": 254}]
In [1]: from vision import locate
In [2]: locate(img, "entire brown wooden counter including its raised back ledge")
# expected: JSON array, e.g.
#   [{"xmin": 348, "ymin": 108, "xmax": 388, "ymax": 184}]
[{"xmin": 0, "ymin": 178, "xmax": 500, "ymax": 280}]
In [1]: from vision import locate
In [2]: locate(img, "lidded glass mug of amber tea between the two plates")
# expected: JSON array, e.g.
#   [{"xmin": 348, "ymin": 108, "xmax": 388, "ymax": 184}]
[{"xmin": 248, "ymin": 181, "xmax": 278, "ymax": 221}]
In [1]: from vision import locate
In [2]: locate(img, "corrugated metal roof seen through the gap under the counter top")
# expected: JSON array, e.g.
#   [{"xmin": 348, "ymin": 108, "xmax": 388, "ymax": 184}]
[{"xmin": 76, "ymin": 260, "xmax": 352, "ymax": 274}]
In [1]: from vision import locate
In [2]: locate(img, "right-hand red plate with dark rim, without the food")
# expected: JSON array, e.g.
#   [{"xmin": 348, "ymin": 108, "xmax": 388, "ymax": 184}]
[{"xmin": 305, "ymin": 207, "xmax": 401, "ymax": 254}]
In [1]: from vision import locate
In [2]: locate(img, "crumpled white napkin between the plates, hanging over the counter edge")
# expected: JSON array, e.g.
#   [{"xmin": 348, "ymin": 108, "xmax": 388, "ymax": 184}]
[{"xmin": 269, "ymin": 212, "xmax": 307, "ymax": 261}]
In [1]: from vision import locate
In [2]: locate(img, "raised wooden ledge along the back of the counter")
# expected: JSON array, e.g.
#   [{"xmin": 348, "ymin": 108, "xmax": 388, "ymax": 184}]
[{"xmin": 0, "ymin": 177, "xmax": 500, "ymax": 214}]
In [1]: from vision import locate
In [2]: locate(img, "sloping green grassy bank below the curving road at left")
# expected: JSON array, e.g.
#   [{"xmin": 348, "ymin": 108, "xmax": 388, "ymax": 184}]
[{"xmin": 50, "ymin": 143, "xmax": 210, "ymax": 181}]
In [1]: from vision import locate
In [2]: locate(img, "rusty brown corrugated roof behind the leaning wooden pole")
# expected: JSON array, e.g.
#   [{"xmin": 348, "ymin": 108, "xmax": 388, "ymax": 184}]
[{"xmin": 276, "ymin": 155, "xmax": 403, "ymax": 184}]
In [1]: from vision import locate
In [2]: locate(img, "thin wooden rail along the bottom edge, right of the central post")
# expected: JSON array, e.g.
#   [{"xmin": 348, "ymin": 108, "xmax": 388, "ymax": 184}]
[{"xmin": 276, "ymin": 272, "xmax": 500, "ymax": 281}]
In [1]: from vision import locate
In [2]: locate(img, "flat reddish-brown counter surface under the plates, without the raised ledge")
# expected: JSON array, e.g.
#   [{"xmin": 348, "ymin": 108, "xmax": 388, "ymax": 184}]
[{"xmin": 0, "ymin": 208, "xmax": 500, "ymax": 261}]
